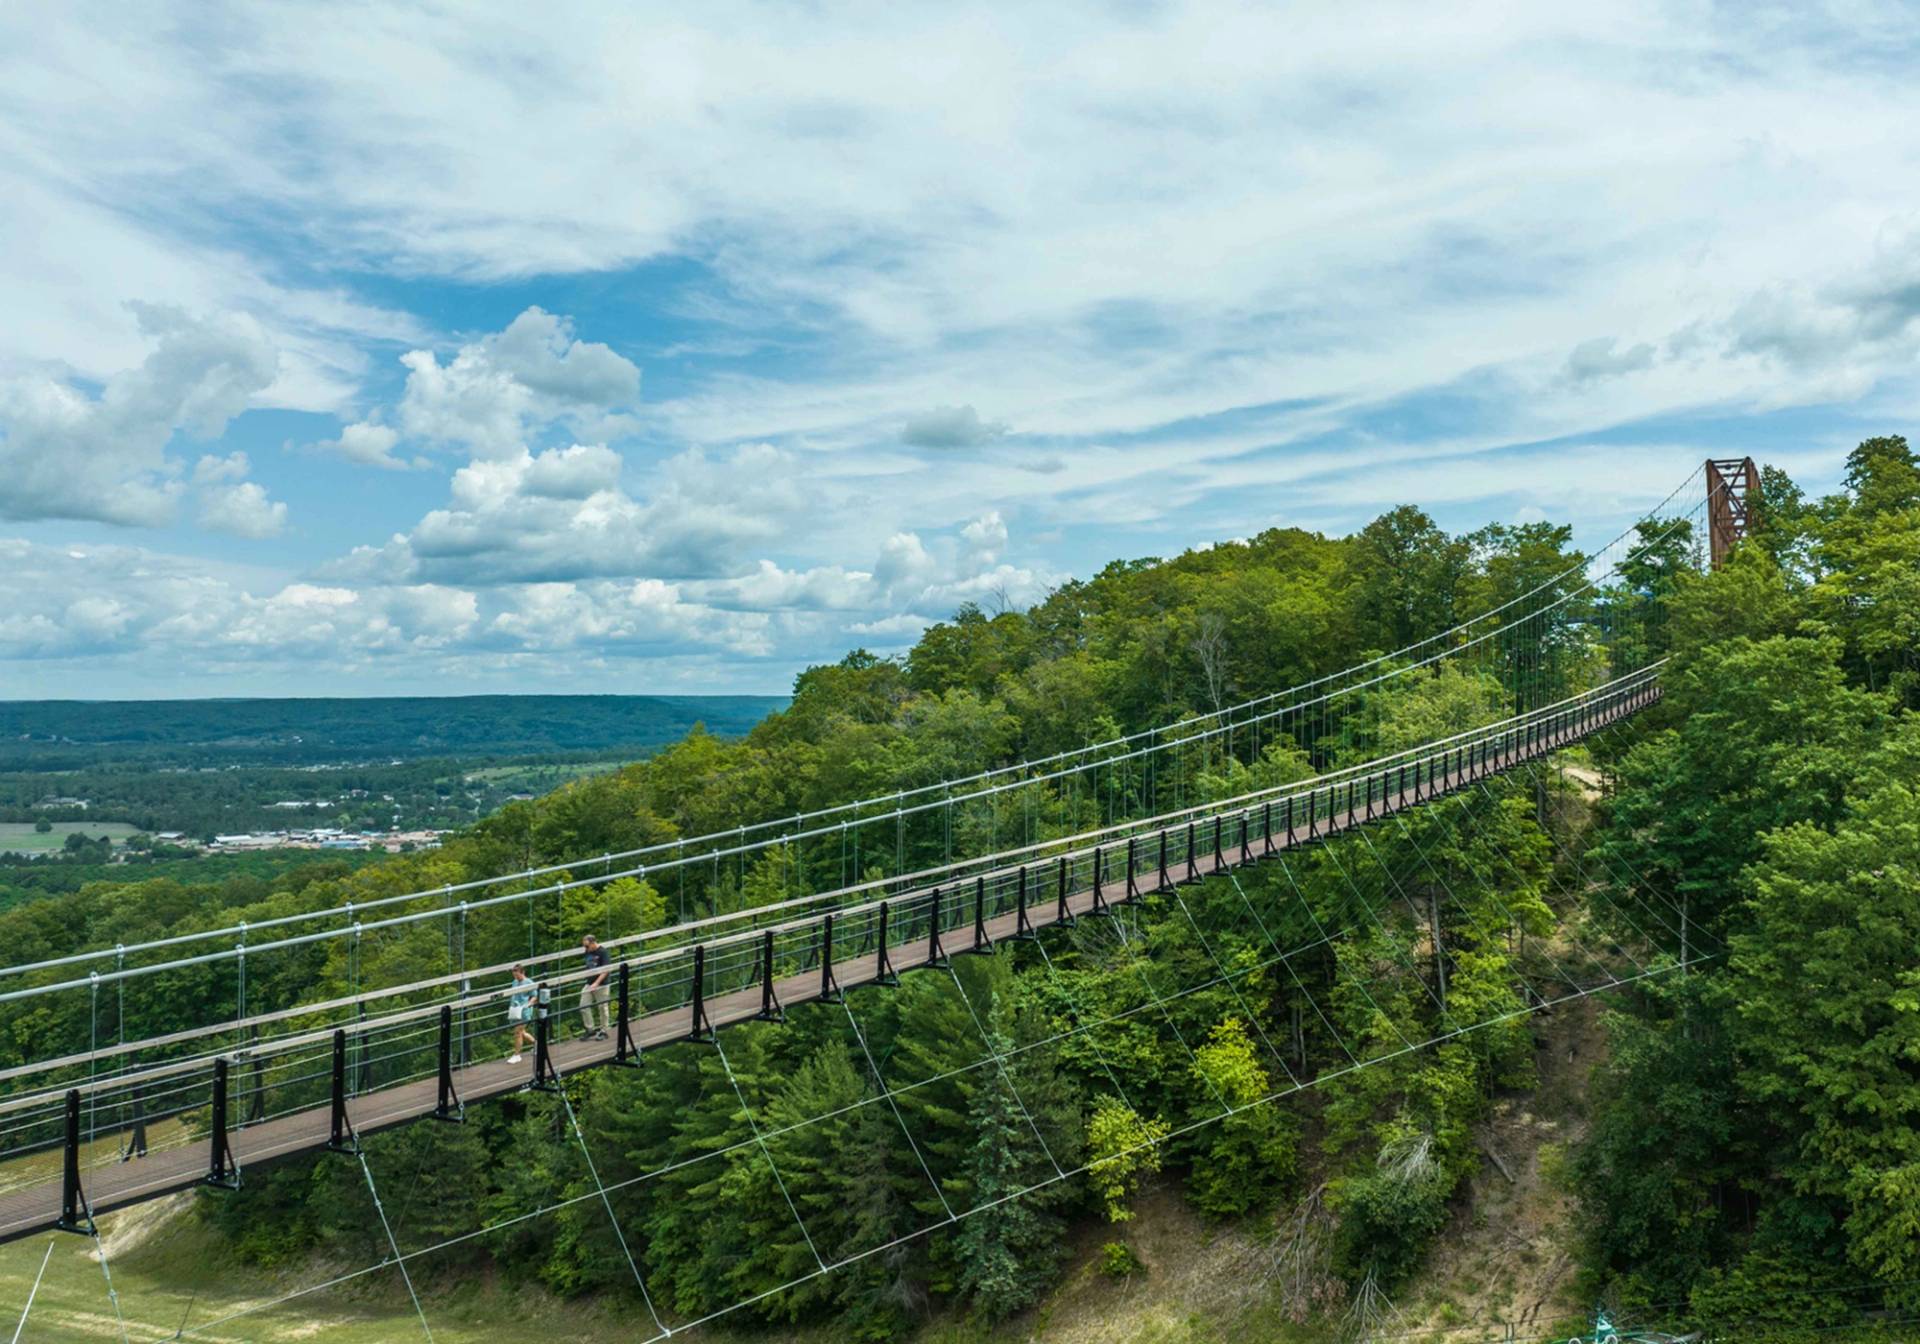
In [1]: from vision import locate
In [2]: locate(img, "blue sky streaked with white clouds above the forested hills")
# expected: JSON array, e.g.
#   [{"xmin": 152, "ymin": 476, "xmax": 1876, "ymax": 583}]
[{"xmin": 0, "ymin": 4, "xmax": 1920, "ymax": 697}]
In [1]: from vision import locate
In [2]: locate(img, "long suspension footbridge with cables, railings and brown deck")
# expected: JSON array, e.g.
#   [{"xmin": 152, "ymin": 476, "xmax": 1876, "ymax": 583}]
[{"xmin": 0, "ymin": 463, "xmax": 1759, "ymax": 1334}]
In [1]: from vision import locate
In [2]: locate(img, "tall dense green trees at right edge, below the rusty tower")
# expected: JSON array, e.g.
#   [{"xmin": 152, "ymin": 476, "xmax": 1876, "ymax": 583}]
[{"xmin": 1578, "ymin": 438, "xmax": 1920, "ymax": 1327}]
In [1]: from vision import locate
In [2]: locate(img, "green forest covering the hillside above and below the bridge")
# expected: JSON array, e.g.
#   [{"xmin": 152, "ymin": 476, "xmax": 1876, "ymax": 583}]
[{"xmin": 0, "ymin": 438, "xmax": 1920, "ymax": 1340}]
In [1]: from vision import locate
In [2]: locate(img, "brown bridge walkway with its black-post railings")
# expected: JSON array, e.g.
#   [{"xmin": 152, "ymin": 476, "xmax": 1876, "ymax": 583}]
[{"xmin": 0, "ymin": 668, "xmax": 1659, "ymax": 1221}]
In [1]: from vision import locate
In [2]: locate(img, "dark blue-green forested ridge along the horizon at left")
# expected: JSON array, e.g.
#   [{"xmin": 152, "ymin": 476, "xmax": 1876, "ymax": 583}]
[{"xmin": 0, "ymin": 695, "xmax": 787, "ymax": 770}]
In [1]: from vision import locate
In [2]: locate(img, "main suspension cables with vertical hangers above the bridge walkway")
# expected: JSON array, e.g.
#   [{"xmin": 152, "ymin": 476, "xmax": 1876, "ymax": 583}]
[{"xmin": 0, "ymin": 483, "xmax": 1728, "ymax": 1048}]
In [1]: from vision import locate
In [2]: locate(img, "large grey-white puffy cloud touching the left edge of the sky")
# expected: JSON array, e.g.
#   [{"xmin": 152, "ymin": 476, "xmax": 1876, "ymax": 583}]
[{"xmin": 0, "ymin": 305, "xmax": 276, "ymax": 526}]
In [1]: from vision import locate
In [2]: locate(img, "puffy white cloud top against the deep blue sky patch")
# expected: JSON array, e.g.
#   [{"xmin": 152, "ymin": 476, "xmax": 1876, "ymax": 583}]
[{"xmin": 399, "ymin": 307, "xmax": 639, "ymax": 459}]
